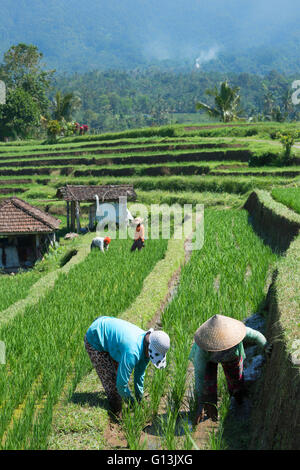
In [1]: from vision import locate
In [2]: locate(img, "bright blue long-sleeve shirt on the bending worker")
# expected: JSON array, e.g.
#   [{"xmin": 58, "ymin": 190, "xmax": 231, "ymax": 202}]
[{"xmin": 86, "ymin": 316, "xmax": 149, "ymax": 400}]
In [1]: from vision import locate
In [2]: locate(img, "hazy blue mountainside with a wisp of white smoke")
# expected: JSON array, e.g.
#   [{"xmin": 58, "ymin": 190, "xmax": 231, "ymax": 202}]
[{"xmin": 0, "ymin": 0, "xmax": 300, "ymax": 73}]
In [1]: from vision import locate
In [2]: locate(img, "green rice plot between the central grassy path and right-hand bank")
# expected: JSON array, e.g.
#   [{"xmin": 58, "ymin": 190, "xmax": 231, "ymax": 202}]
[{"xmin": 125, "ymin": 210, "xmax": 277, "ymax": 450}]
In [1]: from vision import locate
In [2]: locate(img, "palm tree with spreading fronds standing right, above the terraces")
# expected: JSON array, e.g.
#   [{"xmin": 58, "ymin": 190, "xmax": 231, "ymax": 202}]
[{"xmin": 196, "ymin": 81, "xmax": 241, "ymax": 122}]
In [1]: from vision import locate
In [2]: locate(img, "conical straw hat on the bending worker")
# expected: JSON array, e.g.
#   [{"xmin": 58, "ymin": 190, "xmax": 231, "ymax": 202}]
[{"xmin": 194, "ymin": 315, "xmax": 246, "ymax": 352}]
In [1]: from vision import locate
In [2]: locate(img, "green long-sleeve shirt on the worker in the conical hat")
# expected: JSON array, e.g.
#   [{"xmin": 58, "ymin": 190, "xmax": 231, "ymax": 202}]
[{"xmin": 189, "ymin": 327, "xmax": 267, "ymax": 397}]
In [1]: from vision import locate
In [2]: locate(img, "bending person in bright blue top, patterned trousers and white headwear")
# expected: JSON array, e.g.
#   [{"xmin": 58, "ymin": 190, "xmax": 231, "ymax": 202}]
[{"xmin": 84, "ymin": 316, "xmax": 170, "ymax": 415}]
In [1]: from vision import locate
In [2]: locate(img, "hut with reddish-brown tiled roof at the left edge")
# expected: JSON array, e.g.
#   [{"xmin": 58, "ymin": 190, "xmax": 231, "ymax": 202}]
[{"xmin": 0, "ymin": 197, "xmax": 60, "ymax": 271}]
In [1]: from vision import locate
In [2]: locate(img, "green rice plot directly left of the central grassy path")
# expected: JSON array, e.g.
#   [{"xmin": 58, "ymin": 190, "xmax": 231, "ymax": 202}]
[{"xmin": 0, "ymin": 240, "xmax": 166, "ymax": 449}]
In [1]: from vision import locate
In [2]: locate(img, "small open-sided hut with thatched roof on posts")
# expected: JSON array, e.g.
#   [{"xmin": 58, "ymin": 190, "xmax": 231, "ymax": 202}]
[{"xmin": 56, "ymin": 184, "xmax": 137, "ymax": 233}]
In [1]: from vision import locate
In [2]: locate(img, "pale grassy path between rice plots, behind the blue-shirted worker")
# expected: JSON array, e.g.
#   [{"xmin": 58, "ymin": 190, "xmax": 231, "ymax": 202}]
[{"xmin": 48, "ymin": 229, "xmax": 190, "ymax": 450}]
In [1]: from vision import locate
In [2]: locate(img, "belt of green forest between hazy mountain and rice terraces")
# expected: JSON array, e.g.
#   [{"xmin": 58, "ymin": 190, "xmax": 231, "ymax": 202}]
[{"xmin": 54, "ymin": 69, "xmax": 300, "ymax": 132}]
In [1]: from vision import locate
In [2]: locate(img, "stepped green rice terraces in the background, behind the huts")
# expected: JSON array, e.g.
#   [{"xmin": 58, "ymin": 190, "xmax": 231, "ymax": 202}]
[{"xmin": 0, "ymin": 128, "xmax": 300, "ymax": 214}]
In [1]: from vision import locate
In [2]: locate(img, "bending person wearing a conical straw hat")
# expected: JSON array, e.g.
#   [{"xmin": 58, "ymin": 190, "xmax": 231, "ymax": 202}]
[{"xmin": 190, "ymin": 315, "xmax": 272, "ymax": 424}]
